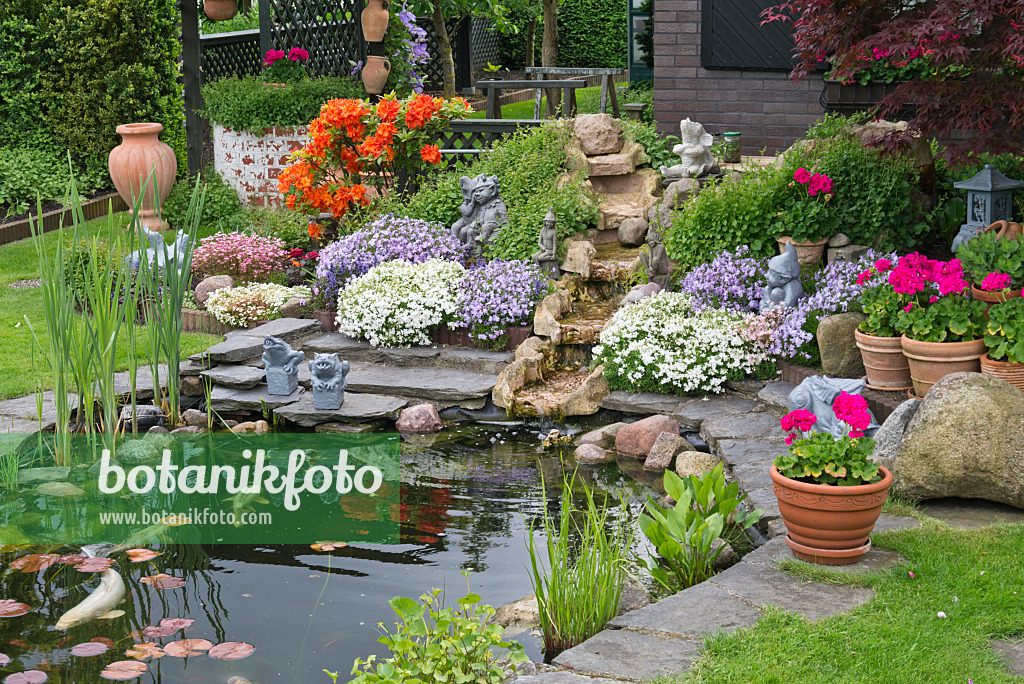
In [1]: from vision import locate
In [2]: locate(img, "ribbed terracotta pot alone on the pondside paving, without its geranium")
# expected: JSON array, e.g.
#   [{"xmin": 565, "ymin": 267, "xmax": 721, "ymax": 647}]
[{"xmin": 771, "ymin": 466, "xmax": 893, "ymax": 565}]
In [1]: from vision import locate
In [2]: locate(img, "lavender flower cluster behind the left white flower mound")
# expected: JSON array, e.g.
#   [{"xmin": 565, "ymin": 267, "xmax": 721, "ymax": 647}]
[{"xmin": 313, "ymin": 214, "xmax": 466, "ymax": 303}]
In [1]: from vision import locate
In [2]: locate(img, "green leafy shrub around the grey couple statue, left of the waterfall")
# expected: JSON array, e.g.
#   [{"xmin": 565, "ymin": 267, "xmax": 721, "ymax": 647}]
[{"xmin": 385, "ymin": 123, "xmax": 597, "ymax": 259}]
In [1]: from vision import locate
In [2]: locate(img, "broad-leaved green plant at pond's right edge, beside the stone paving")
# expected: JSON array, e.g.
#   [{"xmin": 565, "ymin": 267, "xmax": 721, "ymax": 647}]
[{"xmin": 638, "ymin": 464, "xmax": 764, "ymax": 593}]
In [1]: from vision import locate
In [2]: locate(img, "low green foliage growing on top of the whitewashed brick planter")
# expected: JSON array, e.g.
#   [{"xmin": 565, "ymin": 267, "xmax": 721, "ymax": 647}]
[{"xmin": 201, "ymin": 76, "xmax": 366, "ymax": 135}]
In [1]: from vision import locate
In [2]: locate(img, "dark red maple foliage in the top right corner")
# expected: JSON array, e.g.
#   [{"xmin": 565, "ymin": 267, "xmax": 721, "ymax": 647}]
[{"xmin": 762, "ymin": 0, "xmax": 1024, "ymax": 158}]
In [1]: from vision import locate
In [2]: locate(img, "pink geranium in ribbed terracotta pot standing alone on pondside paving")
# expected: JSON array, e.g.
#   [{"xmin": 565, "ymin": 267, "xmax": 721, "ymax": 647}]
[{"xmin": 771, "ymin": 392, "xmax": 893, "ymax": 565}]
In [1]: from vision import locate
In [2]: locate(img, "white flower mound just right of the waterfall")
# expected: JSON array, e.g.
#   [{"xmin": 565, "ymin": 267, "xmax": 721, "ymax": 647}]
[{"xmin": 594, "ymin": 293, "xmax": 762, "ymax": 393}]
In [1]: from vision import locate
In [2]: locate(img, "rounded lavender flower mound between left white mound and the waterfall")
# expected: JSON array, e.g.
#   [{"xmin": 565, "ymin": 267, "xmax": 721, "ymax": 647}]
[{"xmin": 453, "ymin": 260, "xmax": 548, "ymax": 340}]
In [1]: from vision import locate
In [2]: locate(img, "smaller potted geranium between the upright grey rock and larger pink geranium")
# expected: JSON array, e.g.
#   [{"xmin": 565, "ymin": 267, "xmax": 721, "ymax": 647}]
[{"xmin": 853, "ymin": 259, "xmax": 912, "ymax": 391}]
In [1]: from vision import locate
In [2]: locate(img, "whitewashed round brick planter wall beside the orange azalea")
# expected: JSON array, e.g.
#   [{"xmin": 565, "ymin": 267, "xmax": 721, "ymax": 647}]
[{"xmin": 213, "ymin": 124, "xmax": 308, "ymax": 207}]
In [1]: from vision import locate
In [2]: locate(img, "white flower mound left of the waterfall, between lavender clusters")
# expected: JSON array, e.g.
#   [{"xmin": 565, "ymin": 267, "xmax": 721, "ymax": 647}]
[{"xmin": 338, "ymin": 259, "xmax": 466, "ymax": 347}]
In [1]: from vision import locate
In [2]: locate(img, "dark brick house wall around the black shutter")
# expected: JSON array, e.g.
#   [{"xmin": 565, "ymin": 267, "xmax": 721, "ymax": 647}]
[{"xmin": 654, "ymin": 0, "xmax": 824, "ymax": 155}]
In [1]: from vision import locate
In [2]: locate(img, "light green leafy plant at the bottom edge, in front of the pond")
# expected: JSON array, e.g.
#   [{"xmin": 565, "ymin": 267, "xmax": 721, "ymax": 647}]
[{"xmin": 342, "ymin": 573, "xmax": 528, "ymax": 684}]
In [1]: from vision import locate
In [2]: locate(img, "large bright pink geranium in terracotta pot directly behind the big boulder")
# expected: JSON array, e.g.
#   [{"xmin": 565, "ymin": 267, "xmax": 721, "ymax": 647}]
[{"xmin": 889, "ymin": 253, "xmax": 986, "ymax": 397}]
